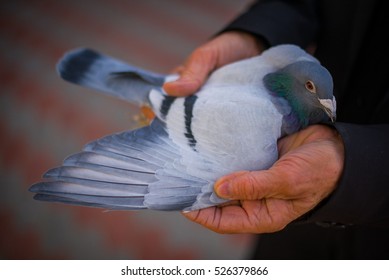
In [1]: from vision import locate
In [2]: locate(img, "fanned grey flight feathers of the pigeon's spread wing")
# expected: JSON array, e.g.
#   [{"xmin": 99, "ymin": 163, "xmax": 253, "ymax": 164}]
[{"xmin": 30, "ymin": 120, "xmax": 219, "ymax": 210}]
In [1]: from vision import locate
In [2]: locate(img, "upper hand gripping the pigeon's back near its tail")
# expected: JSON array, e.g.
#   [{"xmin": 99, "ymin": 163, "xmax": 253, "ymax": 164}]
[{"xmin": 163, "ymin": 31, "xmax": 265, "ymax": 96}]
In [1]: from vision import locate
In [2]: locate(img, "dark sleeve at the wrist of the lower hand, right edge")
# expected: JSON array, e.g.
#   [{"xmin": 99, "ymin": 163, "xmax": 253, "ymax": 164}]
[{"xmin": 306, "ymin": 123, "xmax": 389, "ymax": 227}]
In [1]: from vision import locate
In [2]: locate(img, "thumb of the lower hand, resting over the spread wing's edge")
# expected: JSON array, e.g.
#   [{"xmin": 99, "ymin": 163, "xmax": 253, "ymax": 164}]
[{"xmin": 215, "ymin": 169, "xmax": 288, "ymax": 200}]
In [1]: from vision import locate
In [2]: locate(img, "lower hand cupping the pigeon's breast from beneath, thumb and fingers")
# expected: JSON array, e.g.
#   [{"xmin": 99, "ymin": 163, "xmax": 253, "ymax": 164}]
[{"xmin": 184, "ymin": 125, "xmax": 344, "ymax": 233}]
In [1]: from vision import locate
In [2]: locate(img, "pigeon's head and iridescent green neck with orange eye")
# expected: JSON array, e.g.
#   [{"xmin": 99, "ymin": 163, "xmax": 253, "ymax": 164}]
[{"xmin": 264, "ymin": 60, "xmax": 336, "ymax": 127}]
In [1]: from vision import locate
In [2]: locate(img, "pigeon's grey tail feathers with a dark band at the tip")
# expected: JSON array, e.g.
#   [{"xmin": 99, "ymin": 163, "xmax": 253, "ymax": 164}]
[{"xmin": 57, "ymin": 48, "xmax": 166, "ymax": 106}]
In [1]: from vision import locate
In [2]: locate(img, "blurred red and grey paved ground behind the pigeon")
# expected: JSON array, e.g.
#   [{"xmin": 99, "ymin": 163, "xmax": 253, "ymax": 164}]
[{"xmin": 0, "ymin": 0, "xmax": 252, "ymax": 259}]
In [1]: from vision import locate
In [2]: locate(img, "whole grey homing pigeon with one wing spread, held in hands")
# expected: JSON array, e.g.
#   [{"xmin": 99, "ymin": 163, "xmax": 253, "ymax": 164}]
[{"xmin": 30, "ymin": 45, "xmax": 336, "ymax": 211}]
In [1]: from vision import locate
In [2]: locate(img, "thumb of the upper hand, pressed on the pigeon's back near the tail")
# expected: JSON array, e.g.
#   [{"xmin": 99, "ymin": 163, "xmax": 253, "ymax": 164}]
[{"xmin": 163, "ymin": 48, "xmax": 217, "ymax": 96}]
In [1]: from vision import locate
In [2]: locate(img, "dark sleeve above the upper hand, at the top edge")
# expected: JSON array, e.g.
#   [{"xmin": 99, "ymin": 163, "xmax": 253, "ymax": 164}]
[{"xmin": 223, "ymin": 0, "xmax": 318, "ymax": 48}]
